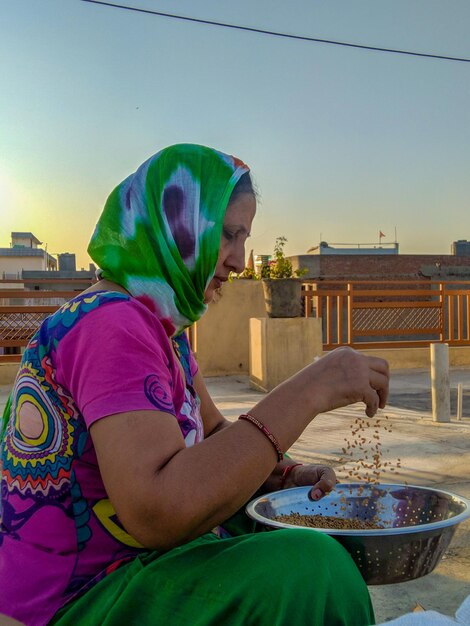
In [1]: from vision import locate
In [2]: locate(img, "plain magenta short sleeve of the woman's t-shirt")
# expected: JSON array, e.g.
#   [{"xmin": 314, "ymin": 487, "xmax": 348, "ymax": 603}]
[{"xmin": 55, "ymin": 300, "xmax": 184, "ymax": 426}]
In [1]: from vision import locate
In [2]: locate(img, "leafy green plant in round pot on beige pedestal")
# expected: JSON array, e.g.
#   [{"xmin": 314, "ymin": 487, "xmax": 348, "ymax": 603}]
[{"xmin": 261, "ymin": 237, "xmax": 307, "ymax": 317}]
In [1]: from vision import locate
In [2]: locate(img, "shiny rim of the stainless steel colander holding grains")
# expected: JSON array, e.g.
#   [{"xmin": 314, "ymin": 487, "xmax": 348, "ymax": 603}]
[{"xmin": 245, "ymin": 483, "xmax": 470, "ymax": 537}]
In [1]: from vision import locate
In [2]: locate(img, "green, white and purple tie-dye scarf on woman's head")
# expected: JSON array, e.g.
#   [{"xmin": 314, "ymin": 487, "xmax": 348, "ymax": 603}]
[{"xmin": 88, "ymin": 144, "xmax": 249, "ymax": 336}]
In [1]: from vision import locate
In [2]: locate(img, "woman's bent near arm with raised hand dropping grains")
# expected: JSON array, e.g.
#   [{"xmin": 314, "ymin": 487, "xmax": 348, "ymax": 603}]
[{"xmin": 90, "ymin": 349, "xmax": 388, "ymax": 549}]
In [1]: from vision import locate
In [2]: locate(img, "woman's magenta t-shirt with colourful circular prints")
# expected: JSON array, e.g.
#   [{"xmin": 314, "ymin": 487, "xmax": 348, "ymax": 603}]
[{"xmin": 0, "ymin": 292, "xmax": 203, "ymax": 626}]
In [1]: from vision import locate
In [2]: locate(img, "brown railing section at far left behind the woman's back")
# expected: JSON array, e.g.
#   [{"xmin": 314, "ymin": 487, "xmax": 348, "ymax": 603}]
[{"xmin": 0, "ymin": 278, "xmax": 91, "ymax": 363}]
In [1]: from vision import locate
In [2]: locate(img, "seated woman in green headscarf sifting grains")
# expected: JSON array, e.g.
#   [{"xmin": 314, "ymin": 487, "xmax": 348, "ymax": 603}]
[{"xmin": 0, "ymin": 144, "xmax": 388, "ymax": 626}]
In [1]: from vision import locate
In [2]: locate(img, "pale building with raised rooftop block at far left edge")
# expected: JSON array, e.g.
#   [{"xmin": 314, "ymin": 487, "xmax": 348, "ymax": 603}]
[{"xmin": 0, "ymin": 232, "xmax": 57, "ymax": 279}]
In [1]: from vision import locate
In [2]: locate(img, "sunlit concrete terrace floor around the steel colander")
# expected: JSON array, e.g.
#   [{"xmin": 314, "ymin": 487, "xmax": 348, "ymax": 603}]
[{"xmin": 0, "ymin": 369, "xmax": 470, "ymax": 622}]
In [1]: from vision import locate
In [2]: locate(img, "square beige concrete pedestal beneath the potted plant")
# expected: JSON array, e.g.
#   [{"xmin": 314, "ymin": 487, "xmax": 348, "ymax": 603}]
[{"xmin": 250, "ymin": 317, "xmax": 323, "ymax": 391}]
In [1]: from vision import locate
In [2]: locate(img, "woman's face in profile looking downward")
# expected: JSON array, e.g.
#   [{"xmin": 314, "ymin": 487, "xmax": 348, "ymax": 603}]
[{"xmin": 204, "ymin": 193, "xmax": 256, "ymax": 303}]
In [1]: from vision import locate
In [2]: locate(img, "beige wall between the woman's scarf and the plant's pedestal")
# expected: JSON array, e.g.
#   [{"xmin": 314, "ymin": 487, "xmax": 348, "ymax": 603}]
[{"xmin": 190, "ymin": 279, "xmax": 266, "ymax": 376}]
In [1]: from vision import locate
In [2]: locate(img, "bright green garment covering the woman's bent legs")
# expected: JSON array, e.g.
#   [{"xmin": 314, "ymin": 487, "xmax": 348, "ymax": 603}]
[{"xmin": 51, "ymin": 517, "xmax": 375, "ymax": 626}]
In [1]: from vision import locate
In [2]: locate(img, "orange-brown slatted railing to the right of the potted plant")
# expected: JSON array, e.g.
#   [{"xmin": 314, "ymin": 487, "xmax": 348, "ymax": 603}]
[{"xmin": 302, "ymin": 281, "xmax": 470, "ymax": 350}]
